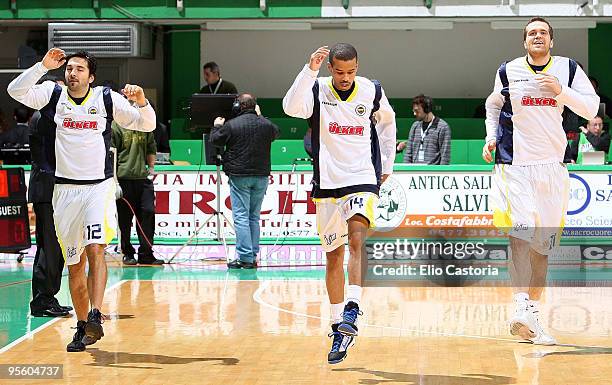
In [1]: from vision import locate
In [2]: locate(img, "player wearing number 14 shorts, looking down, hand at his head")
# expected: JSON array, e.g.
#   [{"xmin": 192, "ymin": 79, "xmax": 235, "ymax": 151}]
[{"xmin": 283, "ymin": 43, "xmax": 396, "ymax": 364}]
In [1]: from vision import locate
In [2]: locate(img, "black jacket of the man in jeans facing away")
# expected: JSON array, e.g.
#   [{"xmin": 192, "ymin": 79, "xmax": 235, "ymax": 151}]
[{"xmin": 210, "ymin": 110, "xmax": 279, "ymax": 176}]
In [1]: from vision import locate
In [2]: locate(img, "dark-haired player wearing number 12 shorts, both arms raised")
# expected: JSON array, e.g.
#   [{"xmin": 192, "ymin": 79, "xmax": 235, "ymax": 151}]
[{"xmin": 8, "ymin": 48, "xmax": 155, "ymax": 352}]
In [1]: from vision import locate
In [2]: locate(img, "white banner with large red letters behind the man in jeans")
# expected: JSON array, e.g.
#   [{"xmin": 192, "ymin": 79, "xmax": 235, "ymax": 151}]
[{"xmin": 149, "ymin": 171, "xmax": 319, "ymax": 241}]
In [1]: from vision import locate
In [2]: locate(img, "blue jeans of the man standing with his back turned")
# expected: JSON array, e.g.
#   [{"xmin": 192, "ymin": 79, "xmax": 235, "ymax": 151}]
[{"xmin": 229, "ymin": 176, "xmax": 268, "ymax": 263}]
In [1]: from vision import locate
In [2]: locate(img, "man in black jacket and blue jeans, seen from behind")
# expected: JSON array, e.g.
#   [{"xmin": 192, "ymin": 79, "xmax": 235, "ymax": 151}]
[{"xmin": 210, "ymin": 94, "xmax": 279, "ymax": 269}]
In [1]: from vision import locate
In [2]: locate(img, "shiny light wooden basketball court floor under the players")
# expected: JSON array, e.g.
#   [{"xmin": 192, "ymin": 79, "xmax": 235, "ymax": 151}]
[{"xmin": 0, "ymin": 255, "xmax": 612, "ymax": 385}]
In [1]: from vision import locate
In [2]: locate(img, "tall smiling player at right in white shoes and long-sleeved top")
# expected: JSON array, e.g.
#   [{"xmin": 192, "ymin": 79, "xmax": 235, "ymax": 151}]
[{"xmin": 482, "ymin": 17, "xmax": 599, "ymax": 345}]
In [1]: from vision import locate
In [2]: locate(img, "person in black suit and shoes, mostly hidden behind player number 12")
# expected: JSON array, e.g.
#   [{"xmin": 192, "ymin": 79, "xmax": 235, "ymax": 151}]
[{"xmin": 28, "ymin": 111, "xmax": 72, "ymax": 317}]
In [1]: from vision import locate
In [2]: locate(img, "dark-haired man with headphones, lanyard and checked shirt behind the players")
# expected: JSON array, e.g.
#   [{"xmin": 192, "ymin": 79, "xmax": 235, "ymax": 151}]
[{"xmin": 397, "ymin": 95, "xmax": 451, "ymax": 164}]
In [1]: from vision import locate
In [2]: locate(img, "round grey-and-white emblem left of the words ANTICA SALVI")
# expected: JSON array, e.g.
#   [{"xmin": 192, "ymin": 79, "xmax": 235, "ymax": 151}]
[{"xmin": 375, "ymin": 176, "xmax": 407, "ymax": 231}]
